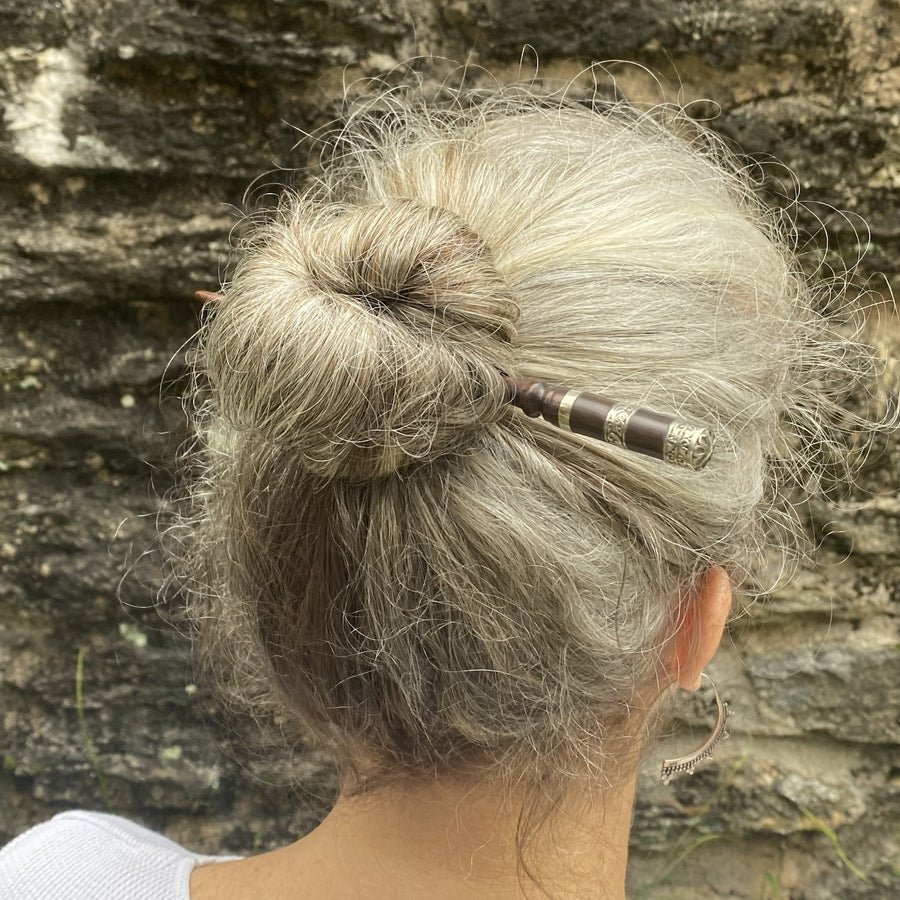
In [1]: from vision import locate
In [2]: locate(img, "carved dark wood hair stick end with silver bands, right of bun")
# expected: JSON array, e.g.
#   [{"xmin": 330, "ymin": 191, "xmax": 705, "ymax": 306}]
[{"xmin": 503, "ymin": 374, "xmax": 715, "ymax": 470}]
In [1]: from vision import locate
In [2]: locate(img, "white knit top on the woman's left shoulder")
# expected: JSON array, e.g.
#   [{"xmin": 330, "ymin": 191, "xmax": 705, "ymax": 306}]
[{"xmin": 0, "ymin": 811, "xmax": 236, "ymax": 900}]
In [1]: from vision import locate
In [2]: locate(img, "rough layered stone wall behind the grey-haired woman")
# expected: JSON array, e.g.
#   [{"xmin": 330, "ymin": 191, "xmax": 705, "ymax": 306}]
[{"xmin": 0, "ymin": 0, "xmax": 900, "ymax": 900}]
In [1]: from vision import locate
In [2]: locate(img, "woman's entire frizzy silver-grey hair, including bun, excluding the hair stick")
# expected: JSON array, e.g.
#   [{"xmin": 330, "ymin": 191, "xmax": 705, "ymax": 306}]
[{"xmin": 172, "ymin": 77, "xmax": 888, "ymax": 784}]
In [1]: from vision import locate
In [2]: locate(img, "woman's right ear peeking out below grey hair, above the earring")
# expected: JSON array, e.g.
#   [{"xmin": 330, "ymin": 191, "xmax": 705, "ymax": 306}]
[{"xmin": 666, "ymin": 566, "xmax": 731, "ymax": 691}]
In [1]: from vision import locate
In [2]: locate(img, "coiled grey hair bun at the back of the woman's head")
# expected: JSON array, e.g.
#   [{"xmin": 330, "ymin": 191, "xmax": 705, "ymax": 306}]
[{"xmin": 202, "ymin": 198, "xmax": 518, "ymax": 481}]
